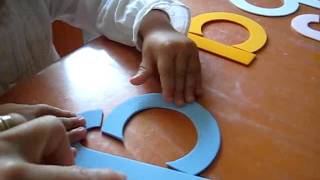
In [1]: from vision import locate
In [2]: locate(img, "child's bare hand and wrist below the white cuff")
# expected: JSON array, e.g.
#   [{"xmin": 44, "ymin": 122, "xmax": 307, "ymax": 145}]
[{"xmin": 131, "ymin": 12, "xmax": 202, "ymax": 105}]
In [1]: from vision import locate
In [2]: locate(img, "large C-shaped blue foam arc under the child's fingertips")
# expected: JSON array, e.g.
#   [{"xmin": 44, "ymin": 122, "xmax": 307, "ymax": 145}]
[{"xmin": 102, "ymin": 93, "xmax": 220, "ymax": 175}]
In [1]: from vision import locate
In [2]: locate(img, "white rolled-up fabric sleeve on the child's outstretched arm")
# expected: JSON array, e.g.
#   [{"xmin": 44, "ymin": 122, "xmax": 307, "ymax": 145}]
[{"xmin": 46, "ymin": 0, "xmax": 191, "ymax": 49}]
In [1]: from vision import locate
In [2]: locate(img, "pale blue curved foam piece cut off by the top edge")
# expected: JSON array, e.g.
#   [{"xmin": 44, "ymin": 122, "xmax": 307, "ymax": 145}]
[{"xmin": 230, "ymin": 0, "xmax": 320, "ymax": 16}]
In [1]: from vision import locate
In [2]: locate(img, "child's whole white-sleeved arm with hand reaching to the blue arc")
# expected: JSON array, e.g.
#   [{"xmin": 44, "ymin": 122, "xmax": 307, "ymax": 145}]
[{"xmin": 45, "ymin": 0, "xmax": 201, "ymax": 104}]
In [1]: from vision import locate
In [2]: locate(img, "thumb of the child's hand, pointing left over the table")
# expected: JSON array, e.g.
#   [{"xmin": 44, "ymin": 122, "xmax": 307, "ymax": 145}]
[{"xmin": 130, "ymin": 58, "xmax": 153, "ymax": 85}]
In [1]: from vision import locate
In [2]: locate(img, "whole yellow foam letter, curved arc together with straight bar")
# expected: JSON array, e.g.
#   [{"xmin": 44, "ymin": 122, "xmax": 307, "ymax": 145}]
[{"xmin": 188, "ymin": 12, "xmax": 267, "ymax": 65}]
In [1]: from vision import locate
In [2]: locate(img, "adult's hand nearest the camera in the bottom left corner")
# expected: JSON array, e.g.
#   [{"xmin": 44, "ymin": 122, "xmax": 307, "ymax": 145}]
[{"xmin": 0, "ymin": 116, "xmax": 124, "ymax": 180}]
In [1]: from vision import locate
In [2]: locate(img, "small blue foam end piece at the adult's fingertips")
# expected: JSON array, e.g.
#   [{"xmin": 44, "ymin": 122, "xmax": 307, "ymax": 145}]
[{"xmin": 78, "ymin": 109, "xmax": 103, "ymax": 130}]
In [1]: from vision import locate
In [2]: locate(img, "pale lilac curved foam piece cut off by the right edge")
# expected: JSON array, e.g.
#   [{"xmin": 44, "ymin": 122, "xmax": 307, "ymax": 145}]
[{"xmin": 291, "ymin": 14, "xmax": 320, "ymax": 41}]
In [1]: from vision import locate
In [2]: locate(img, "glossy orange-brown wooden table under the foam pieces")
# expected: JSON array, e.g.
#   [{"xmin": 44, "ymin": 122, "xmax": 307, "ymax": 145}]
[{"xmin": 1, "ymin": 0, "xmax": 320, "ymax": 180}]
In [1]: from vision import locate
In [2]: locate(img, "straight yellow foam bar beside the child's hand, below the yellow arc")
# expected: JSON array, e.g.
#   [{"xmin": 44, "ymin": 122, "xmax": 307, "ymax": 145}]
[{"xmin": 188, "ymin": 33, "xmax": 256, "ymax": 65}]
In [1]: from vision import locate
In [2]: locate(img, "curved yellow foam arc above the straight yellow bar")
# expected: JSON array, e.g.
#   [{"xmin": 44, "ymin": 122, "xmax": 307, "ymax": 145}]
[{"xmin": 189, "ymin": 12, "xmax": 267, "ymax": 53}]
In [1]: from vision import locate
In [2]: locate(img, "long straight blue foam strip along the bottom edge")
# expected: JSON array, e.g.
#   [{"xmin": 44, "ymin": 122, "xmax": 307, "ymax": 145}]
[{"xmin": 75, "ymin": 143, "xmax": 205, "ymax": 180}]
